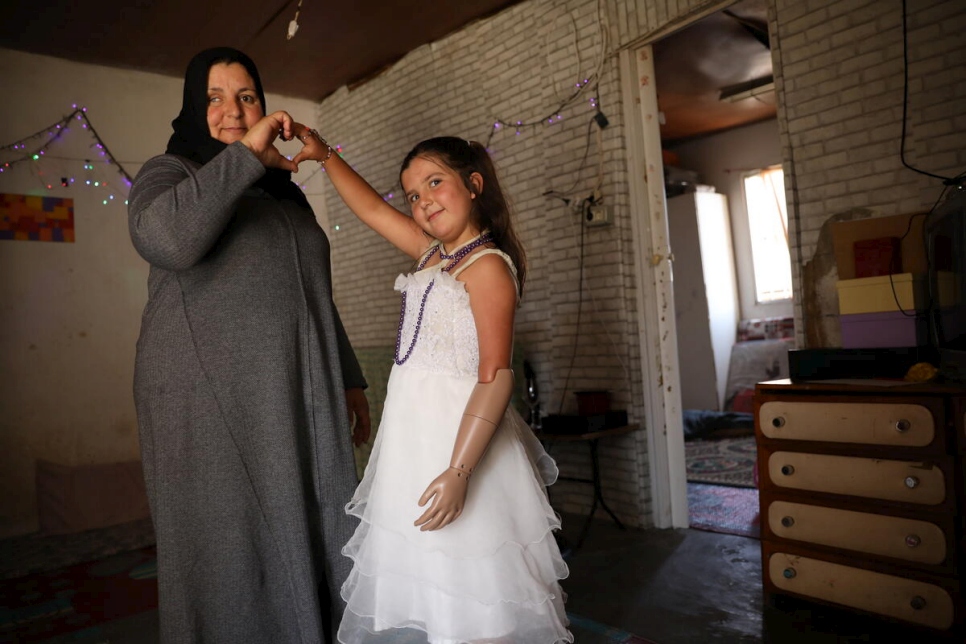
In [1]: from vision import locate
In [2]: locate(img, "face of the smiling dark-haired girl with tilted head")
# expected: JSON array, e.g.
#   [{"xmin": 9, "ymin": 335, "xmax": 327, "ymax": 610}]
[{"xmin": 401, "ymin": 156, "xmax": 483, "ymax": 250}]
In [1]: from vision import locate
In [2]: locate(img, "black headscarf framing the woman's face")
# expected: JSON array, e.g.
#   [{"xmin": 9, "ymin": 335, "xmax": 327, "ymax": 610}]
[{"xmin": 166, "ymin": 47, "xmax": 308, "ymax": 205}]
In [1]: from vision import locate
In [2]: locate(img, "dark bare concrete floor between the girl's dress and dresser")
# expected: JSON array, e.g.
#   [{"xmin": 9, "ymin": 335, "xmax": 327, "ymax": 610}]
[{"xmin": 563, "ymin": 516, "xmax": 964, "ymax": 644}]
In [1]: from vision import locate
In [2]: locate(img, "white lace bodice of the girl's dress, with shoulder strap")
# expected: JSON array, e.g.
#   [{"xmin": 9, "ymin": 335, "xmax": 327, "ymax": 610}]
[{"xmin": 395, "ymin": 245, "xmax": 516, "ymax": 379}]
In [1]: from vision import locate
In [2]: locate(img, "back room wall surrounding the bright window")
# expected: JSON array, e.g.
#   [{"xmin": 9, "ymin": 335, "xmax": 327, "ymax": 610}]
[{"xmin": 671, "ymin": 119, "xmax": 793, "ymax": 319}]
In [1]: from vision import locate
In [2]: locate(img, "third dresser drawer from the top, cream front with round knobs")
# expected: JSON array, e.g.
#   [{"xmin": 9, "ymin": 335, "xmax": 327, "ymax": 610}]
[{"xmin": 762, "ymin": 500, "xmax": 955, "ymax": 566}]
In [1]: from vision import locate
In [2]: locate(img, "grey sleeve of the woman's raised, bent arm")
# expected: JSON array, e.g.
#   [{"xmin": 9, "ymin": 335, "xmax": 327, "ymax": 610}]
[{"xmin": 128, "ymin": 143, "xmax": 265, "ymax": 271}]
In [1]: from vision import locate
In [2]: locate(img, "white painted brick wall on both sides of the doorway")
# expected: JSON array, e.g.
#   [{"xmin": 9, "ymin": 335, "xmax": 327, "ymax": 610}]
[{"xmin": 318, "ymin": 0, "xmax": 966, "ymax": 525}]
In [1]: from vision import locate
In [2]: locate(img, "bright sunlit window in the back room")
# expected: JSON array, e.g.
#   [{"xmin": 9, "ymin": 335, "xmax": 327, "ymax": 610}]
[{"xmin": 744, "ymin": 167, "xmax": 792, "ymax": 303}]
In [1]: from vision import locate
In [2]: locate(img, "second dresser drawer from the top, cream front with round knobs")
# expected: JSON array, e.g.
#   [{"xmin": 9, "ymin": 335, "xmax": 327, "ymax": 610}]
[{"xmin": 762, "ymin": 451, "xmax": 952, "ymax": 506}]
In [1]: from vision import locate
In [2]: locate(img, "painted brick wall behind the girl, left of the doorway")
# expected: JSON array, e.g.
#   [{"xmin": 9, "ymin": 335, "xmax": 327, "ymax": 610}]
[{"xmin": 318, "ymin": 0, "xmax": 720, "ymax": 525}]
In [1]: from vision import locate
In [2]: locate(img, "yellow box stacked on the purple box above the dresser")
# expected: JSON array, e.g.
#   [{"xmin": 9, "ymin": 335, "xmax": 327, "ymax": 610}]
[{"xmin": 835, "ymin": 273, "xmax": 929, "ymax": 315}]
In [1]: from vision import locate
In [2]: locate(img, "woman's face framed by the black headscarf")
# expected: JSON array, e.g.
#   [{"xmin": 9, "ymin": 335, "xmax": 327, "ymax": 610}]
[{"xmin": 208, "ymin": 63, "xmax": 265, "ymax": 143}]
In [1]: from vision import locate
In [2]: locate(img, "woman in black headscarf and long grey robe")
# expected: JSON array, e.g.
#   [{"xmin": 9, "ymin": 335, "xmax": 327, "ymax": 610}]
[{"xmin": 129, "ymin": 48, "xmax": 369, "ymax": 643}]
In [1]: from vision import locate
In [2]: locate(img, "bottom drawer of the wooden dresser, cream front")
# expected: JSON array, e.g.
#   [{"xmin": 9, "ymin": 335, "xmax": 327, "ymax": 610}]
[{"xmin": 765, "ymin": 550, "xmax": 956, "ymax": 630}]
